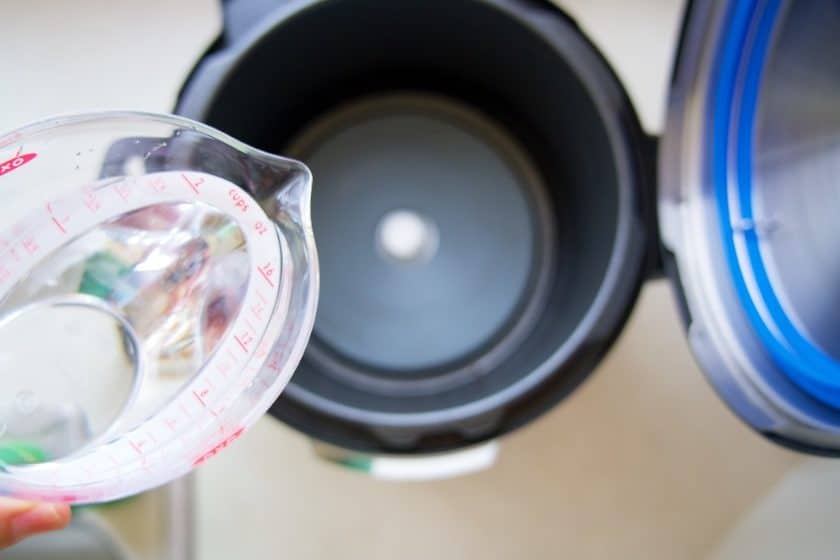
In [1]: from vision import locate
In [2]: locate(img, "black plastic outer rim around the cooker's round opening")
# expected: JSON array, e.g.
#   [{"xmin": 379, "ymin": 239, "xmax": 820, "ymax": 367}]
[{"xmin": 176, "ymin": 0, "xmax": 664, "ymax": 453}]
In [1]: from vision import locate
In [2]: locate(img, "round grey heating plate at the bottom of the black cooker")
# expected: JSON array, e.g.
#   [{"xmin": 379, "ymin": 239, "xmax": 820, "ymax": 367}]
[{"xmin": 287, "ymin": 94, "xmax": 555, "ymax": 383}]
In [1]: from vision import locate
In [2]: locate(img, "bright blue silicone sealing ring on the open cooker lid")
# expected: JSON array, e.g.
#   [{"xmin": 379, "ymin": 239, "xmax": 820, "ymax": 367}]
[{"xmin": 708, "ymin": 0, "xmax": 840, "ymax": 408}]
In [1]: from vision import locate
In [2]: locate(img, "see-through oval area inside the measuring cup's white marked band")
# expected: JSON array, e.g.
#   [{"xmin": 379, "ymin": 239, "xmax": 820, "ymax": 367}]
[{"xmin": 0, "ymin": 192, "xmax": 250, "ymax": 469}]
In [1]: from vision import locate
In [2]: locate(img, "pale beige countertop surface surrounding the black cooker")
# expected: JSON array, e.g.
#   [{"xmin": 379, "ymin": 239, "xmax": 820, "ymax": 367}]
[{"xmin": 0, "ymin": 0, "xmax": 833, "ymax": 560}]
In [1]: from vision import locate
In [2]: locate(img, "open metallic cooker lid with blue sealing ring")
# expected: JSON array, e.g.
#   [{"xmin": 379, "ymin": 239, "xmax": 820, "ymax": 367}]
[{"xmin": 659, "ymin": 0, "xmax": 840, "ymax": 452}]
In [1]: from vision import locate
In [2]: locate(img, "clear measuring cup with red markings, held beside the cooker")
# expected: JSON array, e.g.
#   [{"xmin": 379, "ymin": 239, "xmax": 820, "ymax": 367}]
[{"xmin": 0, "ymin": 112, "xmax": 318, "ymax": 503}]
